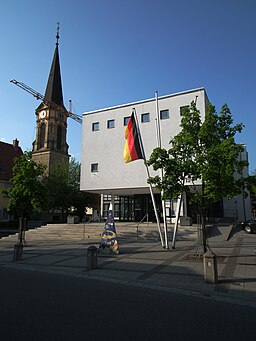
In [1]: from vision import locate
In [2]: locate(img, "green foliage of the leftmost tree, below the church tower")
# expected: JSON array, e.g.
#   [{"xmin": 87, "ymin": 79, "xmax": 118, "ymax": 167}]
[{"xmin": 3, "ymin": 152, "xmax": 45, "ymax": 217}]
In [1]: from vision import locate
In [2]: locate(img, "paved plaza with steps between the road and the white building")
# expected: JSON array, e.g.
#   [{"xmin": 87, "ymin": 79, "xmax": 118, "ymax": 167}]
[{"xmin": 0, "ymin": 224, "xmax": 256, "ymax": 307}]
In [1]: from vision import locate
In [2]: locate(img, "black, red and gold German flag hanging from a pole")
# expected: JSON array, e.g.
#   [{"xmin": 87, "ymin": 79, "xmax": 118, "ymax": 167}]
[{"xmin": 124, "ymin": 113, "xmax": 144, "ymax": 163}]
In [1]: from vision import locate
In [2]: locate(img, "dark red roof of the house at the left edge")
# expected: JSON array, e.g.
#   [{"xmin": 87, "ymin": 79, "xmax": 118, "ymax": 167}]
[{"xmin": 0, "ymin": 139, "xmax": 23, "ymax": 181}]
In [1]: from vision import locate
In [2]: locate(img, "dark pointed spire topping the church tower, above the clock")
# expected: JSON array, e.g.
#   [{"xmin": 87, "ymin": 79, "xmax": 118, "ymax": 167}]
[{"xmin": 45, "ymin": 23, "xmax": 63, "ymax": 106}]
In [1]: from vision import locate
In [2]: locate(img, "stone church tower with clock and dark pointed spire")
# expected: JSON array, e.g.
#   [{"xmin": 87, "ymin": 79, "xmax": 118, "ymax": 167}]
[{"xmin": 32, "ymin": 27, "xmax": 69, "ymax": 174}]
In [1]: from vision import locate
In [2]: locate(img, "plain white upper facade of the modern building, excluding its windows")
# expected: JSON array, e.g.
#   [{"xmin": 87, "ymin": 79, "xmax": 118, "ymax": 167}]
[{"xmin": 81, "ymin": 88, "xmax": 207, "ymax": 195}]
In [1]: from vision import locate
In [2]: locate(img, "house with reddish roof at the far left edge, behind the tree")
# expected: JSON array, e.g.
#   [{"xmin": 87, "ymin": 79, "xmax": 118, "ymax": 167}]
[{"xmin": 0, "ymin": 139, "xmax": 23, "ymax": 221}]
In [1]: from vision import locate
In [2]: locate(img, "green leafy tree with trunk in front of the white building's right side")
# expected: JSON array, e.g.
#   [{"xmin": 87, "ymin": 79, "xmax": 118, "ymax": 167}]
[{"xmin": 148, "ymin": 102, "xmax": 246, "ymax": 252}]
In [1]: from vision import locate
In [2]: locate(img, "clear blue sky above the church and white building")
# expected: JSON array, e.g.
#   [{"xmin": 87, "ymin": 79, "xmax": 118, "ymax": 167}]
[{"xmin": 0, "ymin": 0, "xmax": 256, "ymax": 171}]
